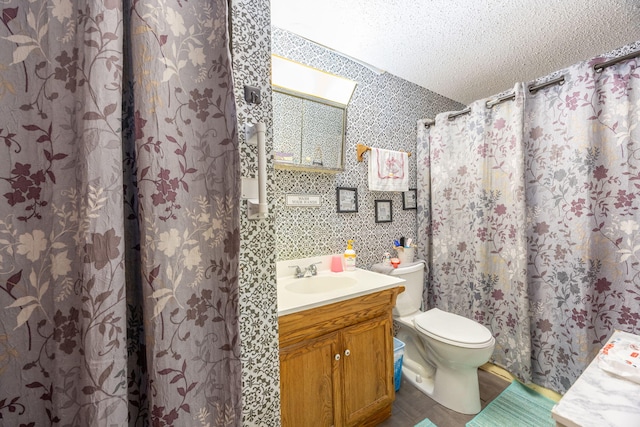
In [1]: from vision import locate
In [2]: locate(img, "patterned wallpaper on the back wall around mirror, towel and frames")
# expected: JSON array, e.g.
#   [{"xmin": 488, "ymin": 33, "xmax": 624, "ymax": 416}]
[{"xmin": 271, "ymin": 28, "xmax": 464, "ymax": 268}]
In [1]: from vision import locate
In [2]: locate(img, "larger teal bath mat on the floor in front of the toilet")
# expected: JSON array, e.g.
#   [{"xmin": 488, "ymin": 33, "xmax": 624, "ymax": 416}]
[{"xmin": 467, "ymin": 381, "xmax": 556, "ymax": 427}]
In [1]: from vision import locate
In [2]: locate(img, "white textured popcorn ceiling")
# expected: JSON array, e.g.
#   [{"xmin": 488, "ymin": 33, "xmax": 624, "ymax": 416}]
[{"xmin": 271, "ymin": 0, "xmax": 640, "ymax": 104}]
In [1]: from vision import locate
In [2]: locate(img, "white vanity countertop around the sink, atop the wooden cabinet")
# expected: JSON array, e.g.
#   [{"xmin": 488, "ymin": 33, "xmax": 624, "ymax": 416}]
[{"xmin": 276, "ymin": 255, "xmax": 404, "ymax": 316}]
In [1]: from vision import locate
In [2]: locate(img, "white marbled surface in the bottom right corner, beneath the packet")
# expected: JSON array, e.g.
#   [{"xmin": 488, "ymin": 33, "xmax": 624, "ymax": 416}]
[{"xmin": 551, "ymin": 331, "xmax": 640, "ymax": 427}]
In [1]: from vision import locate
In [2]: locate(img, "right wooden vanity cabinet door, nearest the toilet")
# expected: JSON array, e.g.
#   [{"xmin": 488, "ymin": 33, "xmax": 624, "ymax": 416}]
[{"xmin": 342, "ymin": 316, "xmax": 395, "ymax": 426}]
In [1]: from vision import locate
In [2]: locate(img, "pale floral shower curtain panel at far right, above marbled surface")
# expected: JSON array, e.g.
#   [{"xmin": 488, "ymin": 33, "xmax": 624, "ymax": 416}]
[{"xmin": 525, "ymin": 55, "xmax": 640, "ymax": 391}]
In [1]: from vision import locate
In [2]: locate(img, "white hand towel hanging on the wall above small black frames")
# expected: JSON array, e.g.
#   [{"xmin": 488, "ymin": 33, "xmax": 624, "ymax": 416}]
[{"xmin": 369, "ymin": 147, "xmax": 409, "ymax": 191}]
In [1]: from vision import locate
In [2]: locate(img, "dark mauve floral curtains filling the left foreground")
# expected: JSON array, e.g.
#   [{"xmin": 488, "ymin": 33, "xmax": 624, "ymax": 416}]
[{"xmin": 0, "ymin": 0, "xmax": 241, "ymax": 426}]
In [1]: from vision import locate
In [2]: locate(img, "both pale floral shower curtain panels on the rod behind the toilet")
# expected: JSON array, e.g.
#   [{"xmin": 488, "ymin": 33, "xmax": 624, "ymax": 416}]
[{"xmin": 418, "ymin": 48, "xmax": 640, "ymax": 392}]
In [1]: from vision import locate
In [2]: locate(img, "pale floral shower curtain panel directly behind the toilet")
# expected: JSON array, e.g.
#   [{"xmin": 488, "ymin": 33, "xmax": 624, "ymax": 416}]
[{"xmin": 418, "ymin": 85, "xmax": 531, "ymax": 380}]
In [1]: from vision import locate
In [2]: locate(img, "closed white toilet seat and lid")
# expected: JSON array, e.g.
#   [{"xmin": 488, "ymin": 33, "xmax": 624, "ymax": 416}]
[{"xmin": 413, "ymin": 308, "xmax": 494, "ymax": 348}]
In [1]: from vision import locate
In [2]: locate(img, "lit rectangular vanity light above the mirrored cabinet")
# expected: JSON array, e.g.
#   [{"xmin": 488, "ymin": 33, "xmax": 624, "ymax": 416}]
[{"xmin": 271, "ymin": 55, "xmax": 357, "ymax": 106}]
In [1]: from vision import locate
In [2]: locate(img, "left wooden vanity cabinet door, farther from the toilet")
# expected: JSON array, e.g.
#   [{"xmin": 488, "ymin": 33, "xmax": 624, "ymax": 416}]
[{"xmin": 280, "ymin": 332, "xmax": 343, "ymax": 427}]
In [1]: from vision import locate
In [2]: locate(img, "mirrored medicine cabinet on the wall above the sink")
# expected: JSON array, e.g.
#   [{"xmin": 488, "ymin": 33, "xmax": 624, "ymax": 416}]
[{"xmin": 273, "ymin": 87, "xmax": 346, "ymax": 173}]
